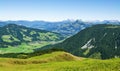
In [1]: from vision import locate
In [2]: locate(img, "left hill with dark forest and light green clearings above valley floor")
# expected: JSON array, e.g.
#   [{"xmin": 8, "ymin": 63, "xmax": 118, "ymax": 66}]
[{"xmin": 0, "ymin": 24, "xmax": 63, "ymax": 47}]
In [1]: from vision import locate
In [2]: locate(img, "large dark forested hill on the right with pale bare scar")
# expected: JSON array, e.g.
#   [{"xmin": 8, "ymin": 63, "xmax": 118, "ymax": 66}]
[{"xmin": 48, "ymin": 24, "xmax": 120, "ymax": 59}]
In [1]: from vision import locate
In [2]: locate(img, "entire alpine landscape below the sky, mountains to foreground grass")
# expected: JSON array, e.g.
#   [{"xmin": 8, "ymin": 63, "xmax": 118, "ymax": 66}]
[{"xmin": 0, "ymin": 20, "xmax": 120, "ymax": 71}]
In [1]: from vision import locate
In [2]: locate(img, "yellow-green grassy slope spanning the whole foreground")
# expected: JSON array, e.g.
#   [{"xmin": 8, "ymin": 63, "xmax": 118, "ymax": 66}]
[{"xmin": 0, "ymin": 52, "xmax": 120, "ymax": 71}]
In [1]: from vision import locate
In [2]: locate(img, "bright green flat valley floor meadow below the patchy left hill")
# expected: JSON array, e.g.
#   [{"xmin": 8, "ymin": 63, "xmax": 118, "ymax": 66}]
[{"xmin": 0, "ymin": 41, "xmax": 53, "ymax": 54}]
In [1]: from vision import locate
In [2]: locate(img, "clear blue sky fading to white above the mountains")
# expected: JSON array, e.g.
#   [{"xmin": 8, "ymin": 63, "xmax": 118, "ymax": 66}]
[{"xmin": 0, "ymin": 0, "xmax": 120, "ymax": 21}]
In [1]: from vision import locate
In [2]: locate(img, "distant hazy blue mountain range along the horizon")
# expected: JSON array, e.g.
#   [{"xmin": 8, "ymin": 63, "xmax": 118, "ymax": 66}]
[{"xmin": 0, "ymin": 20, "xmax": 120, "ymax": 37}]
